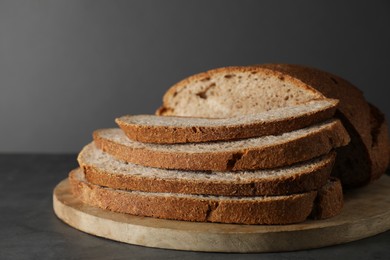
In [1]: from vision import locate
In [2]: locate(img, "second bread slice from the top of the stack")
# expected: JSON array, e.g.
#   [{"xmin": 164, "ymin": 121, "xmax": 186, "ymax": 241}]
[{"xmin": 93, "ymin": 120, "xmax": 349, "ymax": 171}]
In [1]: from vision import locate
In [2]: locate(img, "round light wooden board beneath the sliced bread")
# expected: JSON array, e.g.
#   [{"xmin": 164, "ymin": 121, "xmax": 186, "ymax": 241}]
[{"xmin": 53, "ymin": 176, "xmax": 390, "ymax": 252}]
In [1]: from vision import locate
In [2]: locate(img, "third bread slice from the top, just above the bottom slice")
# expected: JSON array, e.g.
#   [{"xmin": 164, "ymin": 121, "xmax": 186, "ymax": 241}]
[{"xmin": 77, "ymin": 143, "xmax": 335, "ymax": 196}]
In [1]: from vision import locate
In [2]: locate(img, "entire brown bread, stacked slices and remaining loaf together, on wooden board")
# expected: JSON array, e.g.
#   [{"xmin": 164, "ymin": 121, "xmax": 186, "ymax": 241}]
[{"xmin": 69, "ymin": 65, "xmax": 389, "ymax": 224}]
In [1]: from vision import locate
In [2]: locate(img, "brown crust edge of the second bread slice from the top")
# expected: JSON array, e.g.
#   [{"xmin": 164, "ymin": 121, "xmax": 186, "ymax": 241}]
[{"xmin": 93, "ymin": 120, "xmax": 349, "ymax": 171}]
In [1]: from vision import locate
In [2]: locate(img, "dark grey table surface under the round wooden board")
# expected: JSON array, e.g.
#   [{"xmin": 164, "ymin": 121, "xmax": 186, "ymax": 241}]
[{"xmin": 0, "ymin": 154, "xmax": 390, "ymax": 259}]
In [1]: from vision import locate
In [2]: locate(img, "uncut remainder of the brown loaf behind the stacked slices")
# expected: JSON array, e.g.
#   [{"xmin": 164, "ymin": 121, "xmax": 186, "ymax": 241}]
[{"xmin": 156, "ymin": 64, "xmax": 388, "ymax": 187}]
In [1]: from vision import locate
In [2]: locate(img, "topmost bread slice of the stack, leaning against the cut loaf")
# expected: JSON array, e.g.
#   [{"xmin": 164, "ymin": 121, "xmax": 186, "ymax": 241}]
[{"xmin": 116, "ymin": 99, "xmax": 338, "ymax": 144}]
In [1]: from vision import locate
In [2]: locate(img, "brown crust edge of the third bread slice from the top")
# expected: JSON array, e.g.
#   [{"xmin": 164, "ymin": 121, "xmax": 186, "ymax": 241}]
[{"xmin": 79, "ymin": 152, "xmax": 336, "ymax": 196}]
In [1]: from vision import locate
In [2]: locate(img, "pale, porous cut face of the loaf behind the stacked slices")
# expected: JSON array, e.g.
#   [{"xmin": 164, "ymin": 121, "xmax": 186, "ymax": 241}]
[{"xmin": 157, "ymin": 66, "xmax": 325, "ymax": 118}]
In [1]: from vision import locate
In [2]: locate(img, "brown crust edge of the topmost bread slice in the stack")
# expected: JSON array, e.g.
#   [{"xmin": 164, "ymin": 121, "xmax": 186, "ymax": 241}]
[{"xmin": 115, "ymin": 100, "xmax": 338, "ymax": 144}]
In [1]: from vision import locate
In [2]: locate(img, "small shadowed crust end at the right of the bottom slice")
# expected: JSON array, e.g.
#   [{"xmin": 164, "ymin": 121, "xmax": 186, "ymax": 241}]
[{"xmin": 311, "ymin": 178, "xmax": 344, "ymax": 219}]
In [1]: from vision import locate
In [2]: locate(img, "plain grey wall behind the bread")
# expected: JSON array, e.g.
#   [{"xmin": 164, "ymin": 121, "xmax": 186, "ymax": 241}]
[{"xmin": 0, "ymin": 0, "xmax": 390, "ymax": 152}]
